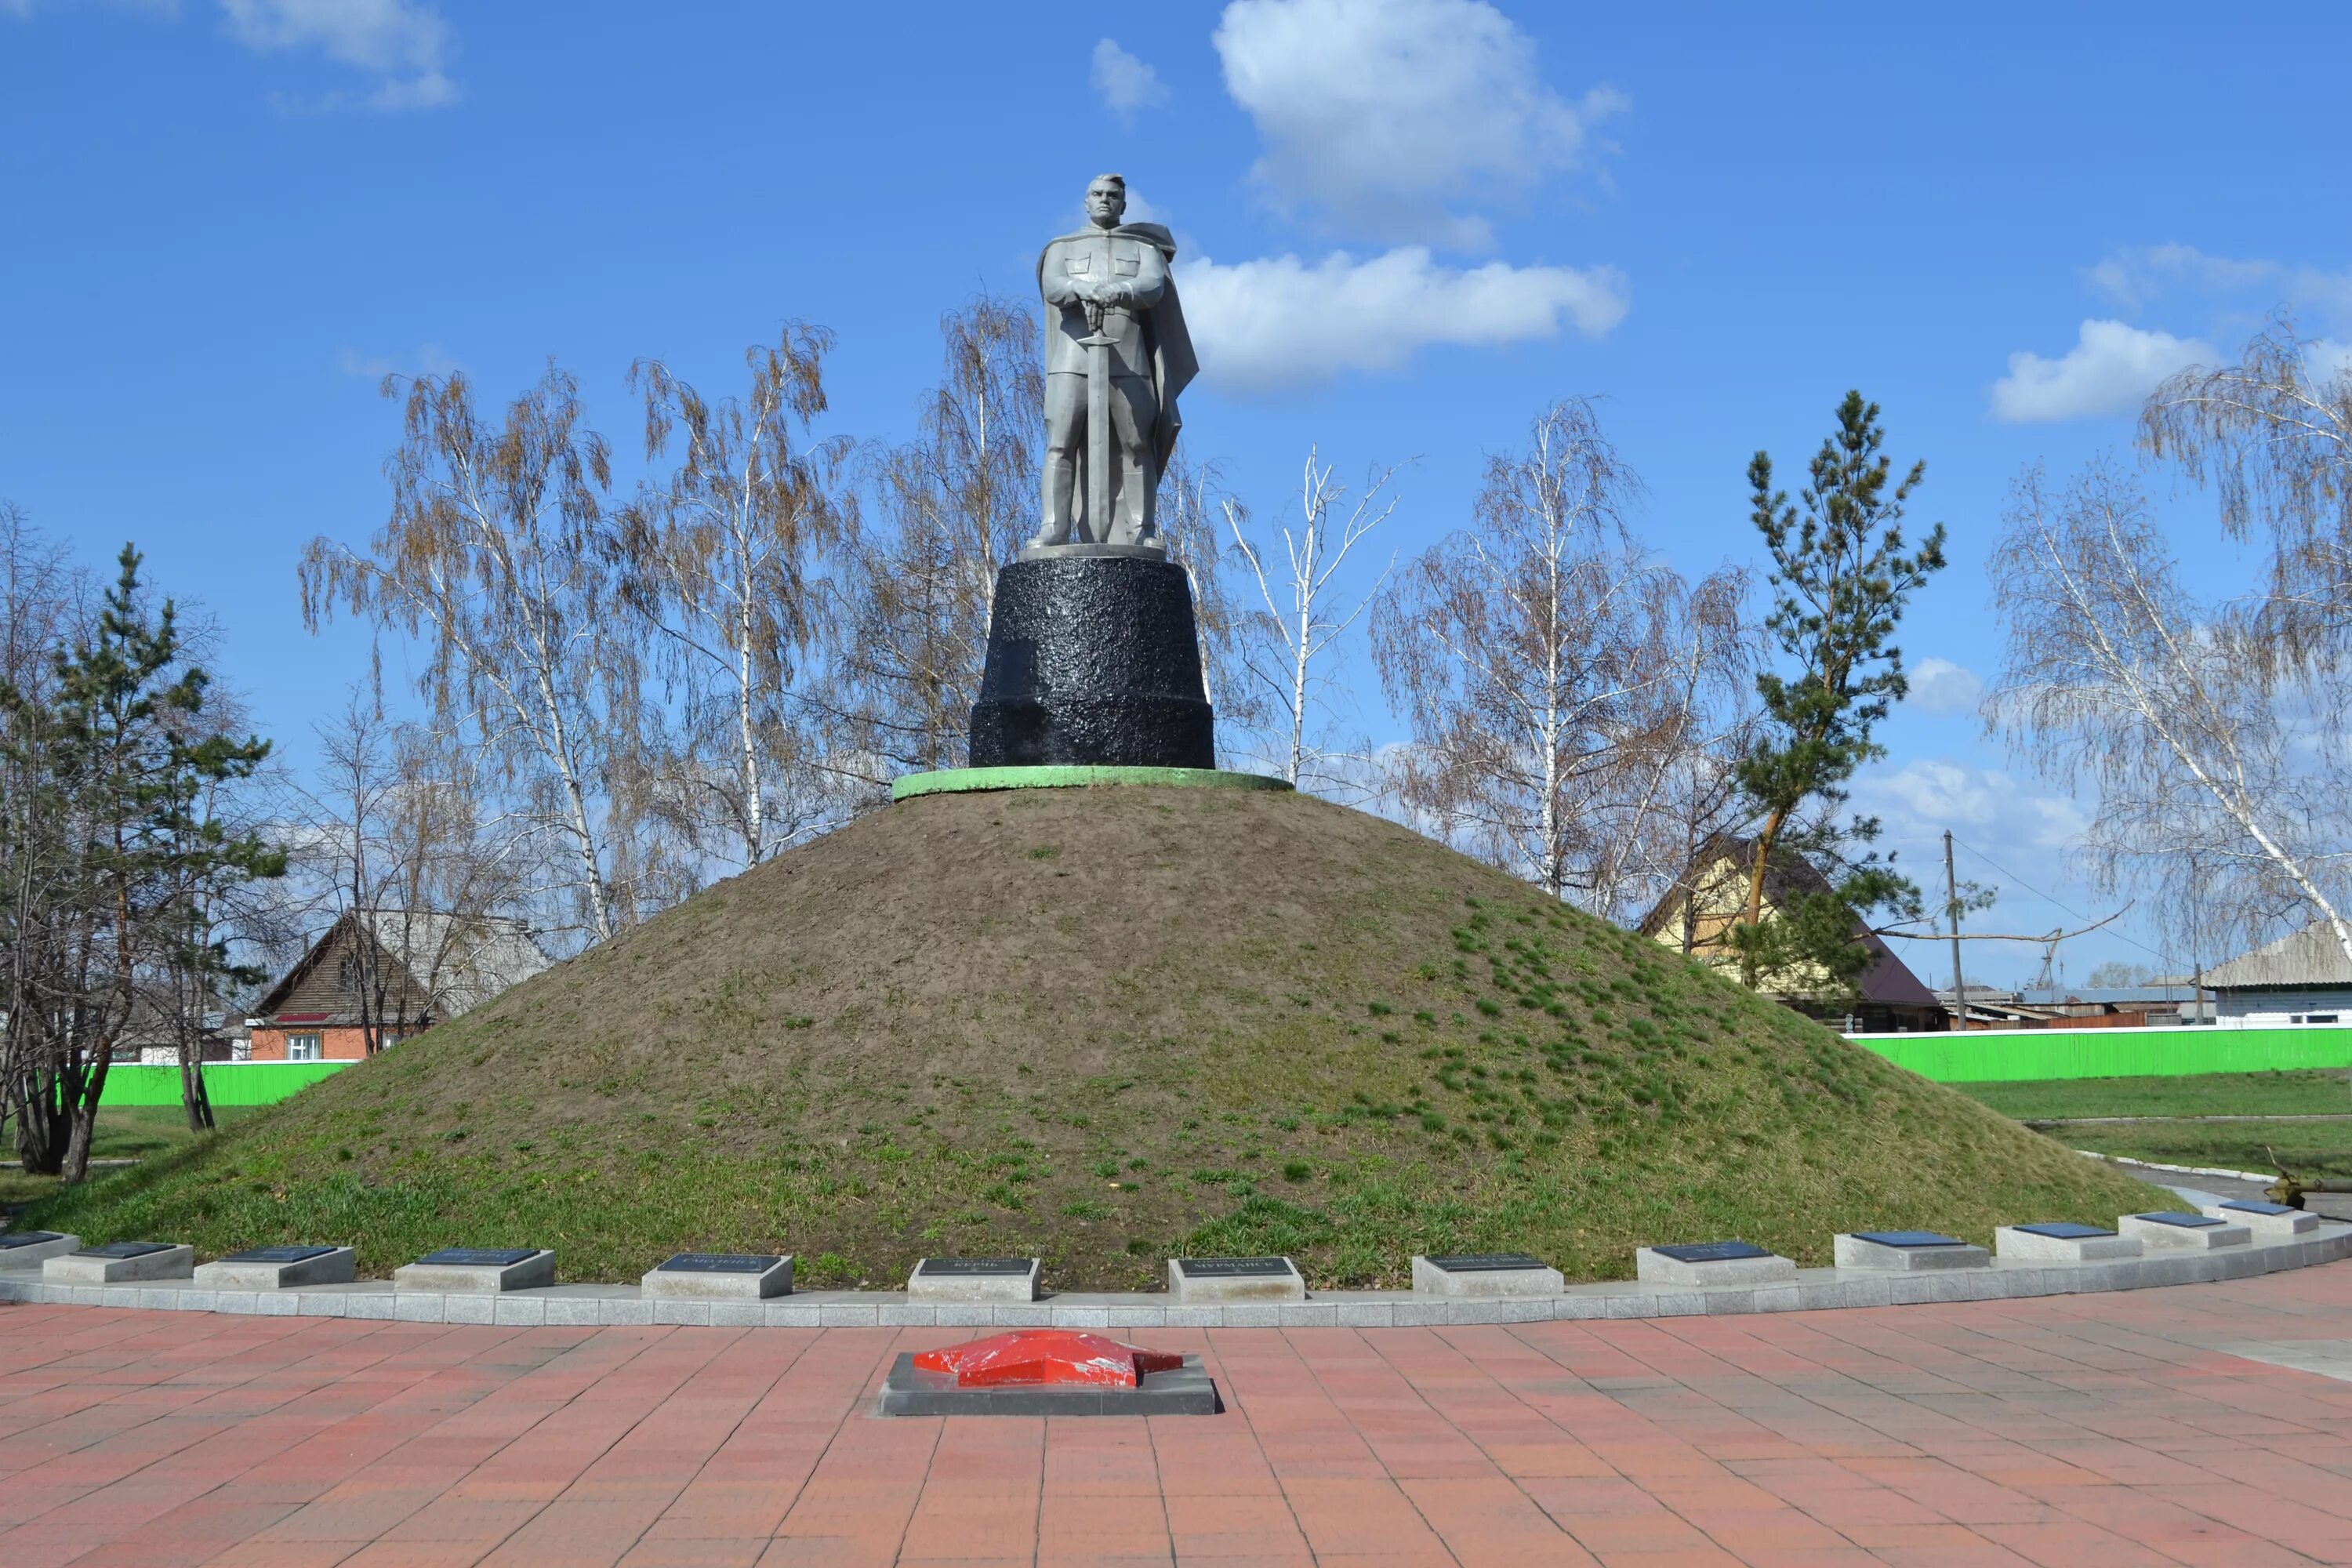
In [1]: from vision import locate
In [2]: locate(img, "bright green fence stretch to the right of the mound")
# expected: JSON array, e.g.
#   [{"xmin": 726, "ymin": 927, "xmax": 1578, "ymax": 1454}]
[{"xmin": 1846, "ymin": 1025, "xmax": 2352, "ymax": 1083}]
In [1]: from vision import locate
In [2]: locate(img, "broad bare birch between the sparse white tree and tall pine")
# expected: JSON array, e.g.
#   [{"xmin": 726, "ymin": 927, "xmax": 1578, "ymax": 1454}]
[{"xmin": 1371, "ymin": 400, "xmax": 1740, "ymax": 914}]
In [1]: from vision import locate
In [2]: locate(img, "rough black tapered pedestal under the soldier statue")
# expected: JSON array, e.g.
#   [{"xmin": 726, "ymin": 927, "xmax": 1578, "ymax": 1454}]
[{"xmin": 971, "ymin": 546, "xmax": 1216, "ymax": 769}]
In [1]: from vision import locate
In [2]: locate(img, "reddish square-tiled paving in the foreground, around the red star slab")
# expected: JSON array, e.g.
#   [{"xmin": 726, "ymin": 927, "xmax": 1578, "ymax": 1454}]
[{"xmin": 0, "ymin": 1262, "xmax": 2352, "ymax": 1568}]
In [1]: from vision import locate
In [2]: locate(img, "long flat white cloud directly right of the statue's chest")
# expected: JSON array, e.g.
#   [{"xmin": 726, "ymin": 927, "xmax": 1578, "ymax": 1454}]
[{"xmin": 1176, "ymin": 247, "xmax": 1625, "ymax": 393}]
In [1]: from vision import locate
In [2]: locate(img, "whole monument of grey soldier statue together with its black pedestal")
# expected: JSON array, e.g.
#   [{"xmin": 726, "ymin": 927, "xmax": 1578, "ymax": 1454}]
[{"xmin": 971, "ymin": 174, "xmax": 1216, "ymax": 769}]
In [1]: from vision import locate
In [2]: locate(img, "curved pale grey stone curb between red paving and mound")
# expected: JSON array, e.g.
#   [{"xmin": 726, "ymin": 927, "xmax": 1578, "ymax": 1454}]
[{"xmin": 0, "ymin": 1220, "xmax": 2352, "ymax": 1328}]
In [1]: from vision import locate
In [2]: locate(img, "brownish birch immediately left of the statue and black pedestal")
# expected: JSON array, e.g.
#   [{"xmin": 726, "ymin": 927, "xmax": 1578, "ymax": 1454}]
[{"xmin": 818, "ymin": 296, "xmax": 1044, "ymax": 794}]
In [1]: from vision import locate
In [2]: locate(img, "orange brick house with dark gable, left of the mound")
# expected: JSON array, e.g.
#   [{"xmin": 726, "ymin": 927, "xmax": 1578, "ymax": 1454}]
[{"xmin": 247, "ymin": 909, "xmax": 553, "ymax": 1062}]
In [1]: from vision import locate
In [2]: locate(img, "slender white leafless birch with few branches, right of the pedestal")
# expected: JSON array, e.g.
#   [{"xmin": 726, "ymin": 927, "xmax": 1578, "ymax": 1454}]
[{"xmin": 1223, "ymin": 447, "xmax": 1397, "ymax": 785}]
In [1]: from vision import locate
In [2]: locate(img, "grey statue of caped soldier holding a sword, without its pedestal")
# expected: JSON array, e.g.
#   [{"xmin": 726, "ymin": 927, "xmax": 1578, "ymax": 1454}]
[{"xmin": 1030, "ymin": 174, "xmax": 1200, "ymax": 550}]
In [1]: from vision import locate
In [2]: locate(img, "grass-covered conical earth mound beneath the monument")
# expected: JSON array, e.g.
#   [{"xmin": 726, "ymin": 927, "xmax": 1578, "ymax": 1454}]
[{"xmin": 26, "ymin": 787, "xmax": 2159, "ymax": 1288}]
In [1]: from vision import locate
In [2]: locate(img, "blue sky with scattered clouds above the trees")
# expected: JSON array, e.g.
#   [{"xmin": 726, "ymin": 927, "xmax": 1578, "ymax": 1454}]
[{"xmin": 0, "ymin": 0, "xmax": 2352, "ymax": 980}]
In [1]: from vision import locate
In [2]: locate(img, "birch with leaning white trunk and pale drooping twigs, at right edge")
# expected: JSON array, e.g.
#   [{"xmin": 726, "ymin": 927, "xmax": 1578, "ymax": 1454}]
[{"xmin": 1987, "ymin": 461, "xmax": 2352, "ymax": 961}]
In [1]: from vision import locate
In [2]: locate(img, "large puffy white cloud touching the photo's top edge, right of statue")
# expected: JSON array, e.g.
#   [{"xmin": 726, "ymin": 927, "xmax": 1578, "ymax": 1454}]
[{"xmin": 1214, "ymin": 0, "xmax": 1625, "ymax": 249}]
